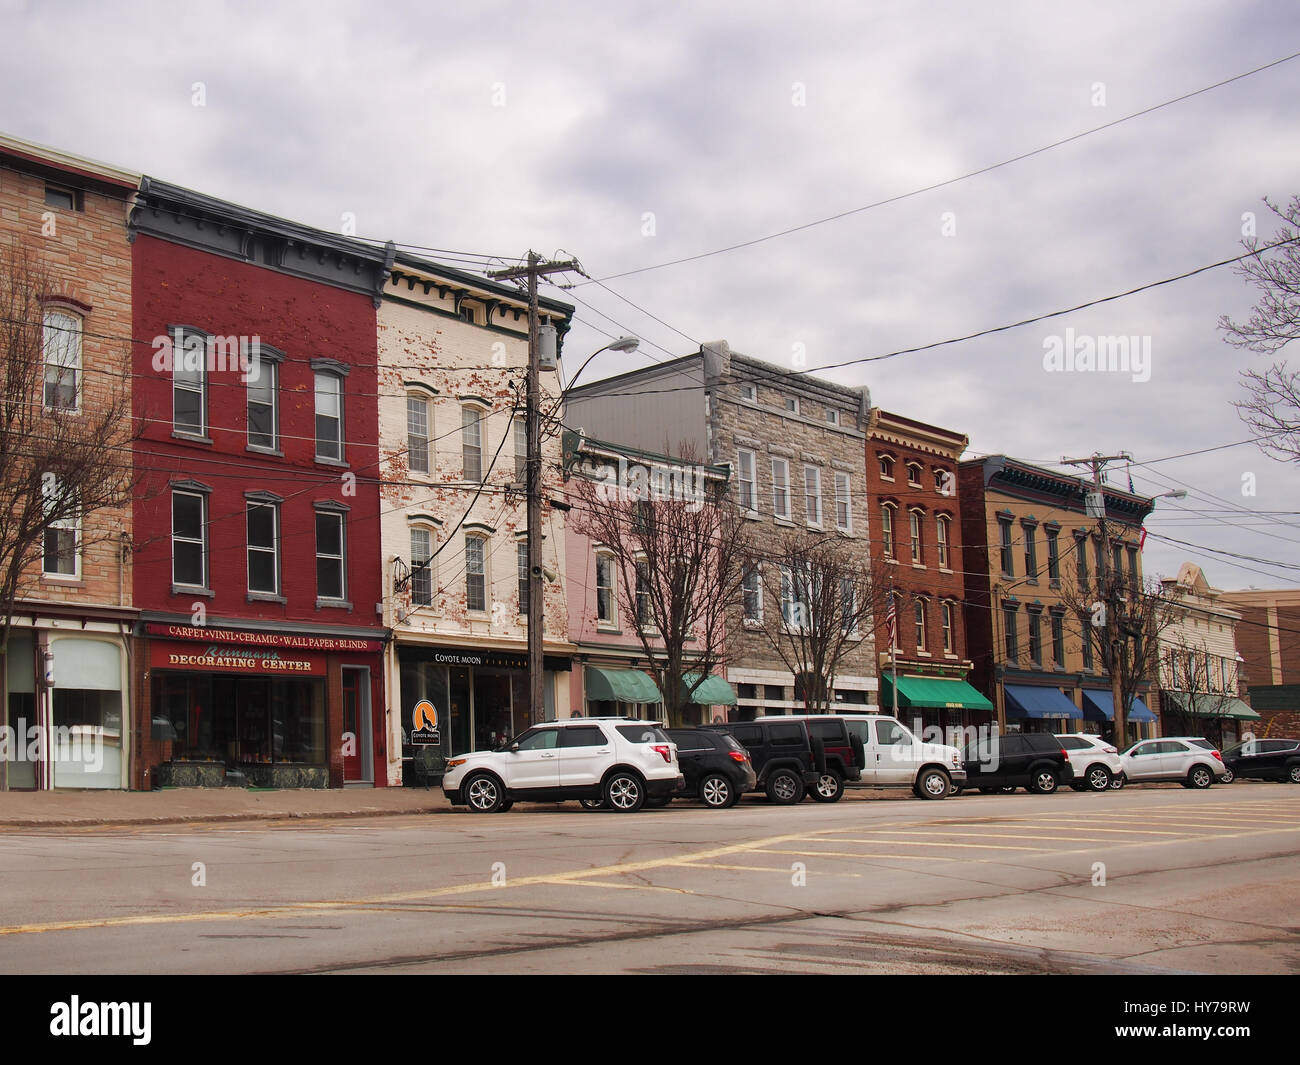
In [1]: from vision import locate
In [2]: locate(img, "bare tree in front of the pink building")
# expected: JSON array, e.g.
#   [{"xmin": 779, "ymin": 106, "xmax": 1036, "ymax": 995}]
[{"xmin": 569, "ymin": 449, "xmax": 749, "ymax": 726}]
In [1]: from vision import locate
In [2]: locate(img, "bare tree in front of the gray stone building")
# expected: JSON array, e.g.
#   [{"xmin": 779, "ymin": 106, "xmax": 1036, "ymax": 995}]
[{"xmin": 748, "ymin": 529, "xmax": 889, "ymax": 713}]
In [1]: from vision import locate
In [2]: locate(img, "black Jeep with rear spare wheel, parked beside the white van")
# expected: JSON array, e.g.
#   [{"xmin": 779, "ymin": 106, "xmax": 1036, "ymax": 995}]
[{"xmin": 706, "ymin": 718, "xmax": 862, "ymax": 805}]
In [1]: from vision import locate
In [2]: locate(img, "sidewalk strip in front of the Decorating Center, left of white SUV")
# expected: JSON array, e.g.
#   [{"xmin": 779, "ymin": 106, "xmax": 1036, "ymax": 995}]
[{"xmin": 0, "ymin": 788, "xmax": 451, "ymax": 828}]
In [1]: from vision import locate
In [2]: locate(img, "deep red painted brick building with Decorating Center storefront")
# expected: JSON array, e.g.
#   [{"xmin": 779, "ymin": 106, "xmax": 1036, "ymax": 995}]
[{"xmin": 129, "ymin": 178, "xmax": 391, "ymax": 788}]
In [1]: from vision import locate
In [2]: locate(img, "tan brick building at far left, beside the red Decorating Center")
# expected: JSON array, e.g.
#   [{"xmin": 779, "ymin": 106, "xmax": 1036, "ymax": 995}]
[{"xmin": 0, "ymin": 137, "xmax": 140, "ymax": 788}]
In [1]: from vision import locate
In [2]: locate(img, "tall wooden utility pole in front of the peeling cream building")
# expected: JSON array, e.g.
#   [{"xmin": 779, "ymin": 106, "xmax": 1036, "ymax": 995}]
[{"xmin": 488, "ymin": 251, "xmax": 579, "ymax": 723}]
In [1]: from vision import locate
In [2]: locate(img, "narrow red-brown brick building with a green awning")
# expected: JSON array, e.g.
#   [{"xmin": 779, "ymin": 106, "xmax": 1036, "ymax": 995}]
[{"xmin": 866, "ymin": 407, "xmax": 992, "ymax": 736}]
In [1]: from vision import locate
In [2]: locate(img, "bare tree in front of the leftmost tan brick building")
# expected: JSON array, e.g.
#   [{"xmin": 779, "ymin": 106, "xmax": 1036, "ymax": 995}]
[{"xmin": 0, "ymin": 238, "xmax": 135, "ymax": 783}]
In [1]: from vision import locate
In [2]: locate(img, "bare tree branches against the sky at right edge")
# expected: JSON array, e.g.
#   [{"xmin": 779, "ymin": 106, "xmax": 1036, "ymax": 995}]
[{"xmin": 1219, "ymin": 196, "xmax": 1300, "ymax": 462}]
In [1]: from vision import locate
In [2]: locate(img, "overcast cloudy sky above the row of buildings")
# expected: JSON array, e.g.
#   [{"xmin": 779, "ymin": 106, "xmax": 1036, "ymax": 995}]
[{"xmin": 0, "ymin": 0, "xmax": 1300, "ymax": 588}]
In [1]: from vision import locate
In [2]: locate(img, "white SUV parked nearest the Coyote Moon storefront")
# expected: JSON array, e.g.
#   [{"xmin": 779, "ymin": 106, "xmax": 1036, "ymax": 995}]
[{"xmin": 442, "ymin": 718, "xmax": 685, "ymax": 814}]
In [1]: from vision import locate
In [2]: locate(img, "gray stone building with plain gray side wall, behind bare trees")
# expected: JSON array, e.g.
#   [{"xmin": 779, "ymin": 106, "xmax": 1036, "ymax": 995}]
[{"xmin": 564, "ymin": 341, "xmax": 878, "ymax": 719}]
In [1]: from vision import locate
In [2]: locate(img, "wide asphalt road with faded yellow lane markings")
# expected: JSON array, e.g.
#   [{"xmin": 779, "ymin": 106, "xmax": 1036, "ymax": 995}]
[{"xmin": 0, "ymin": 782, "xmax": 1300, "ymax": 974}]
